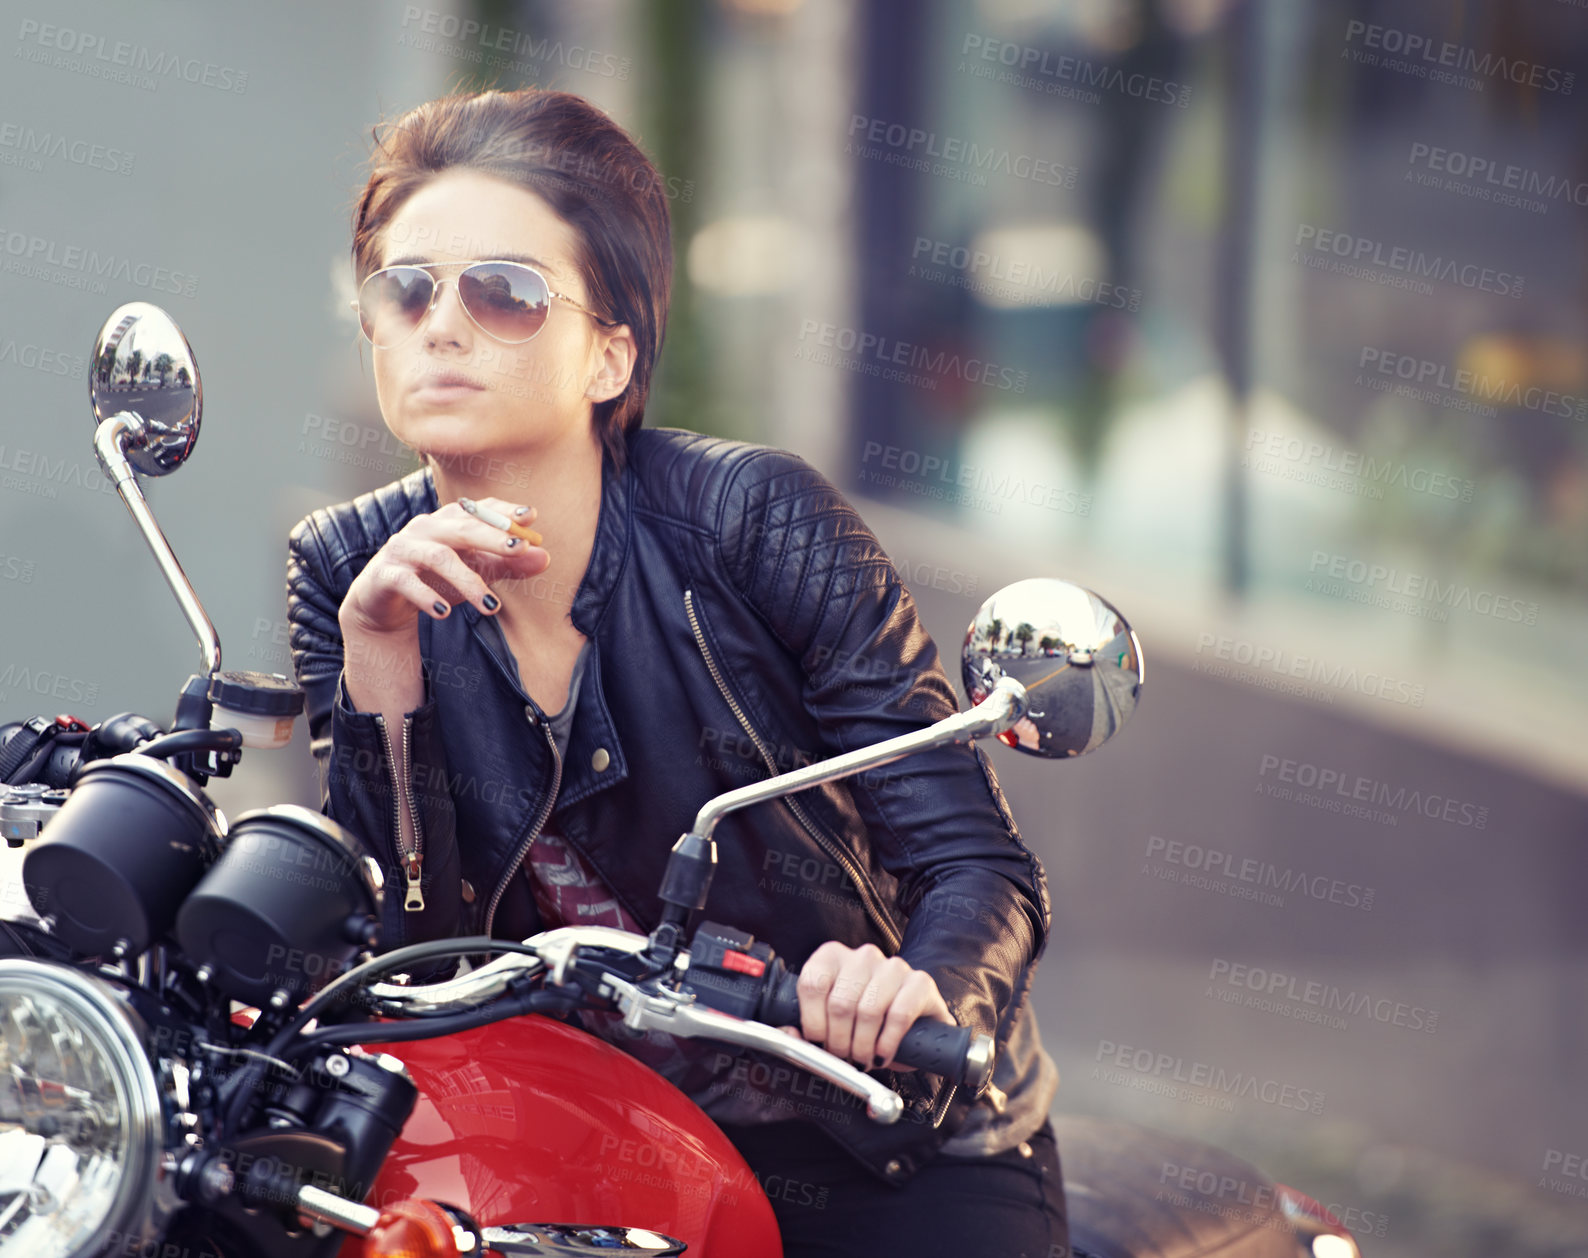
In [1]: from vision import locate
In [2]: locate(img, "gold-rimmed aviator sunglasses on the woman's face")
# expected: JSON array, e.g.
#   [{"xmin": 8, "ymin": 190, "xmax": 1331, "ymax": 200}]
[{"xmin": 351, "ymin": 262, "xmax": 616, "ymax": 349}]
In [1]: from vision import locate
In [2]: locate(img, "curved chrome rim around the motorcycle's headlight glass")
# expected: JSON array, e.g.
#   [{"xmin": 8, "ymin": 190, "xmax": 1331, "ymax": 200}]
[{"xmin": 0, "ymin": 958, "xmax": 164, "ymax": 1253}]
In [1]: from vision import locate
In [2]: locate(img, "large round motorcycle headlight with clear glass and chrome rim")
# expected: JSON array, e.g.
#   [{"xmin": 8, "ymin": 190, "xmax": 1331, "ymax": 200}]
[{"xmin": 0, "ymin": 958, "xmax": 162, "ymax": 1258}]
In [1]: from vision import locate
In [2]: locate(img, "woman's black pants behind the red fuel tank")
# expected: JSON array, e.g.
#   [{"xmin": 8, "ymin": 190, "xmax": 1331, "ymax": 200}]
[{"xmin": 724, "ymin": 1123, "xmax": 1069, "ymax": 1258}]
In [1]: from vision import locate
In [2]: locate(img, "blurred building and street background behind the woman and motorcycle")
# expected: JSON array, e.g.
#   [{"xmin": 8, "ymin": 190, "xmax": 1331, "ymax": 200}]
[{"xmin": 0, "ymin": 0, "xmax": 1588, "ymax": 1255}]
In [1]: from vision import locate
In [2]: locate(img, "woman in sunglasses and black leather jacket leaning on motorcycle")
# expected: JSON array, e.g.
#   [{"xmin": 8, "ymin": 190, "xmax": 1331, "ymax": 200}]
[{"xmin": 287, "ymin": 91, "xmax": 1067, "ymax": 1258}]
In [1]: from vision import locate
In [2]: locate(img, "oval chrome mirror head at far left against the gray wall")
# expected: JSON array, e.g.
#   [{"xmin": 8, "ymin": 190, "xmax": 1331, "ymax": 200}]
[{"xmin": 89, "ymin": 302, "xmax": 203, "ymax": 477}]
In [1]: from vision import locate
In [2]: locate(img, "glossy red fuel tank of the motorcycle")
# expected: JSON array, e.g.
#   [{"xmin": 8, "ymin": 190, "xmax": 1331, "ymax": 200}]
[{"xmin": 343, "ymin": 1017, "xmax": 783, "ymax": 1258}]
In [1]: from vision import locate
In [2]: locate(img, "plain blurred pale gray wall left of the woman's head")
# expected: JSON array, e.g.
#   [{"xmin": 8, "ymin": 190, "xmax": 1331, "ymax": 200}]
[{"xmin": 0, "ymin": 3, "xmax": 476, "ymax": 810}]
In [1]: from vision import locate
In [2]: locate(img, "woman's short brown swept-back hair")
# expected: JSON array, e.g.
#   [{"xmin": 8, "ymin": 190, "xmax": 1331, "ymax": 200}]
[{"xmin": 353, "ymin": 87, "xmax": 673, "ymax": 467}]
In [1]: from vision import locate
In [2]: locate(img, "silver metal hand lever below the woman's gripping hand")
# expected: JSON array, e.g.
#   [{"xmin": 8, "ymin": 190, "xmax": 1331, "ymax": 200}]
[{"xmin": 602, "ymin": 974, "xmax": 904, "ymax": 1123}]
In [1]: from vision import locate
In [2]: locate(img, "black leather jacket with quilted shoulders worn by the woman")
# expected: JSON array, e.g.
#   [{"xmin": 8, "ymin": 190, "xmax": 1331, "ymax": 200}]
[{"xmin": 287, "ymin": 429, "xmax": 1048, "ymax": 1182}]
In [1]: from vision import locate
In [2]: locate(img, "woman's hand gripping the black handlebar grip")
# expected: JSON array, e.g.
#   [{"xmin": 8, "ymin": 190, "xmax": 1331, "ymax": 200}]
[{"xmin": 799, "ymin": 940, "xmax": 954, "ymax": 1071}]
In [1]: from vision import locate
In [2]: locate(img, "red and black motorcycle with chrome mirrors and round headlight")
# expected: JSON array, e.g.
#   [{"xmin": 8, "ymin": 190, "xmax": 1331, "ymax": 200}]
[{"xmin": 0, "ymin": 303, "xmax": 1356, "ymax": 1258}]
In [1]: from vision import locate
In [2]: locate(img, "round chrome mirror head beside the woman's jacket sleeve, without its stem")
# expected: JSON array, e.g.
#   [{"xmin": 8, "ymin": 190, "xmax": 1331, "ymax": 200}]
[{"xmin": 961, "ymin": 577, "xmax": 1145, "ymax": 759}]
